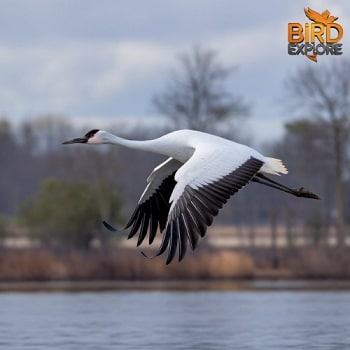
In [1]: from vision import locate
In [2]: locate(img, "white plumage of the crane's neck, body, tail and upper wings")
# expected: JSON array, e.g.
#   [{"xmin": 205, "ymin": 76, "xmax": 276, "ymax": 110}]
[{"xmin": 88, "ymin": 130, "xmax": 288, "ymax": 207}]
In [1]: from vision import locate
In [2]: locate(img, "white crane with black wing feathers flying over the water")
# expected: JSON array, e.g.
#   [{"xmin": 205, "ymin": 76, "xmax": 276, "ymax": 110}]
[{"xmin": 63, "ymin": 129, "xmax": 319, "ymax": 264}]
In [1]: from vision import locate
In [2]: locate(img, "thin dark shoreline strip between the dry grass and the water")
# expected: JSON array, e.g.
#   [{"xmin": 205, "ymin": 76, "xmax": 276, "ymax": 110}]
[{"xmin": 0, "ymin": 279, "xmax": 350, "ymax": 293}]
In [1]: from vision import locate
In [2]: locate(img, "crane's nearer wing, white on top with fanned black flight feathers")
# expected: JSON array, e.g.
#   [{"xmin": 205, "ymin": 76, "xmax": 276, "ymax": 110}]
[{"xmin": 152, "ymin": 146, "xmax": 264, "ymax": 264}]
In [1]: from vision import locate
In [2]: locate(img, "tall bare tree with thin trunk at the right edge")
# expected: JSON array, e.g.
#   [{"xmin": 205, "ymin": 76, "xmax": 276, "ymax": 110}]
[{"xmin": 286, "ymin": 61, "xmax": 350, "ymax": 247}]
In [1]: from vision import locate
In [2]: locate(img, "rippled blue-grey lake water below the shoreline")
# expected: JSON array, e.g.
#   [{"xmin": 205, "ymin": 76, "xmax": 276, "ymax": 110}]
[{"xmin": 0, "ymin": 290, "xmax": 350, "ymax": 350}]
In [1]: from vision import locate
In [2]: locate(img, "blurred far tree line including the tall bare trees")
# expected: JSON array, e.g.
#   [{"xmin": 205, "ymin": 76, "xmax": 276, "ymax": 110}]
[{"xmin": 0, "ymin": 47, "xmax": 350, "ymax": 246}]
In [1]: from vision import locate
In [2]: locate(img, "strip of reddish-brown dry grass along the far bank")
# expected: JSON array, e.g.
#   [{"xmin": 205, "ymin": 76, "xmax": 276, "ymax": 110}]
[{"xmin": 0, "ymin": 247, "xmax": 350, "ymax": 282}]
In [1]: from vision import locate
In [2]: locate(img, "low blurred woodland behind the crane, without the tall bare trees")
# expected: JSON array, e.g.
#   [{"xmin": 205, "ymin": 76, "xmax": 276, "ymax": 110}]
[{"xmin": 0, "ymin": 112, "xmax": 350, "ymax": 246}]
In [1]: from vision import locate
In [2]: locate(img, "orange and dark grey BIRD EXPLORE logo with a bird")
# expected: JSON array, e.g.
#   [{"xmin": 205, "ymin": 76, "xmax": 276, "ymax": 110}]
[{"xmin": 288, "ymin": 7, "xmax": 343, "ymax": 62}]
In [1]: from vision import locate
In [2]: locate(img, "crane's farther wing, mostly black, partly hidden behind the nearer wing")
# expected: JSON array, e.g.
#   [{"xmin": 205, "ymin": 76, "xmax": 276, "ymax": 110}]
[{"xmin": 125, "ymin": 158, "xmax": 182, "ymax": 246}]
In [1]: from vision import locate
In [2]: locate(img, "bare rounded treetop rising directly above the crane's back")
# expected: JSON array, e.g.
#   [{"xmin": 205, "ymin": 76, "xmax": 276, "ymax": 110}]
[{"xmin": 153, "ymin": 46, "xmax": 249, "ymax": 131}]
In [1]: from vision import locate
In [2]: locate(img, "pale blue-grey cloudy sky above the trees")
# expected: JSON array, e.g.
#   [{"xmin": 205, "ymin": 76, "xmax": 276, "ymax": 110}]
[{"xmin": 0, "ymin": 0, "xmax": 350, "ymax": 140}]
